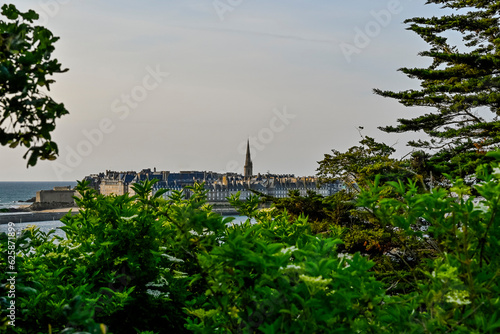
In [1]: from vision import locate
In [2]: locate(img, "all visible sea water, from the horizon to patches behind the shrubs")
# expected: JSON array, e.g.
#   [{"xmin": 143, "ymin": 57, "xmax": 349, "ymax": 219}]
[{"xmin": 0, "ymin": 181, "xmax": 247, "ymax": 238}]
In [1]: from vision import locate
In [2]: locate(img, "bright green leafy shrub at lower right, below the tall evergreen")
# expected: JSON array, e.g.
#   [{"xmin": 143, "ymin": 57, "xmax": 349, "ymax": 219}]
[{"xmin": 359, "ymin": 152, "xmax": 500, "ymax": 333}]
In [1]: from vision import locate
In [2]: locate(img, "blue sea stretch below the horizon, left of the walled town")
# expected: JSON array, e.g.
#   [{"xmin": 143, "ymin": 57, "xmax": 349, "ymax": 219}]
[{"xmin": 0, "ymin": 181, "xmax": 76, "ymax": 209}]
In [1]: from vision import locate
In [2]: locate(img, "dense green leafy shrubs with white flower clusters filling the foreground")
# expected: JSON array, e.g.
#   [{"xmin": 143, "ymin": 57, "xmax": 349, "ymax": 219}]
[{"xmin": 0, "ymin": 153, "xmax": 500, "ymax": 333}]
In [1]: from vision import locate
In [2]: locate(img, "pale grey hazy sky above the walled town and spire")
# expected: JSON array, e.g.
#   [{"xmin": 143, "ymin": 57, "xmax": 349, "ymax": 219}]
[{"xmin": 0, "ymin": 0, "xmax": 443, "ymax": 181}]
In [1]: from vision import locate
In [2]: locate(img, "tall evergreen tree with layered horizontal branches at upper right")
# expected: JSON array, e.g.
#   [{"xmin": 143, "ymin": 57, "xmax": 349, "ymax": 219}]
[{"xmin": 374, "ymin": 0, "xmax": 500, "ymax": 175}]
